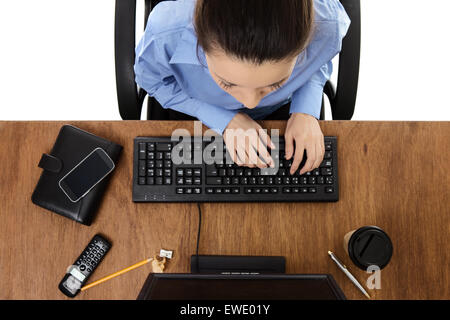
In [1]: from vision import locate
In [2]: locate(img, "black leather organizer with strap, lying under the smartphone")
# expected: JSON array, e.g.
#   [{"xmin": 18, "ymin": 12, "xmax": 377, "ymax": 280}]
[{"xmin": 31, "ymin": 125, "xmax": 122, "ymax": 226}]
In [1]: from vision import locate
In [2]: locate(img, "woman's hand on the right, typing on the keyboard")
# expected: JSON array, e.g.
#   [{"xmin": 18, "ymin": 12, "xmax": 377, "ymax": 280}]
[{"xmin": 284, "ymin": 113, "xmax": 325, "ymax": 174}]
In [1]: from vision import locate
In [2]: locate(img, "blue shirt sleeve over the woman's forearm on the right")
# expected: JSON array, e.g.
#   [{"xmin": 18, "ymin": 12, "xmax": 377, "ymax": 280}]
[{"xmin": 289, "ymin": 61, "xmax": 333, "ymax": 119}]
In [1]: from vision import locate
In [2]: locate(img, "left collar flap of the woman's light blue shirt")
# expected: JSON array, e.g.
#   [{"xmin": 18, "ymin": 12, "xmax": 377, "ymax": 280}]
[{"xmin": 169, "ymin": 24, "xmax": 207, "ymax": 67}]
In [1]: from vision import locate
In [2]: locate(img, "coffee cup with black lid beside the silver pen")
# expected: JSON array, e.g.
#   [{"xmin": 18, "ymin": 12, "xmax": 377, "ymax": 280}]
[{"xmin": 344, "ymin": 226, "xmax": 393, "ymax": 271}]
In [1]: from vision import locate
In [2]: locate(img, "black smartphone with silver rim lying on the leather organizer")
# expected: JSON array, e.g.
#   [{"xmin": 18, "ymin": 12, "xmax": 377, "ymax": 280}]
[{"xmin": 59, "ymin": 148, "xmax": 115, "ymax": 202}]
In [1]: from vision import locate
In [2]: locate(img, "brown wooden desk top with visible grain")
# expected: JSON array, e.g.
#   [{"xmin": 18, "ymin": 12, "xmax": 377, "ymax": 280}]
[{"xmin": 0, "ymin": 121, "xmax": 450, "ymax": 299}]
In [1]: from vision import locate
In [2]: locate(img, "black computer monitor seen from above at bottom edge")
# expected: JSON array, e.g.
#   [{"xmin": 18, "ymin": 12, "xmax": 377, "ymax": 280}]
[{"xmin": 138, "ymin": 273, "xmax": 345, "ymax": 300}]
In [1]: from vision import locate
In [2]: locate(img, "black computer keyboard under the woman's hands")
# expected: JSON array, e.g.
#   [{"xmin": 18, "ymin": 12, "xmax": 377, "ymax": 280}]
[{"xmin": 133, "ymin": 137, "xmax": 339, "ymax": 202}]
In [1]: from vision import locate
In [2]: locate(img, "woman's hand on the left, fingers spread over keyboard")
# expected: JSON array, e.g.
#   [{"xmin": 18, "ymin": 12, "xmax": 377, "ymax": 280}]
[{"xmin": 223, "ymin": 113, "xmax": 275, "ymax": 168}]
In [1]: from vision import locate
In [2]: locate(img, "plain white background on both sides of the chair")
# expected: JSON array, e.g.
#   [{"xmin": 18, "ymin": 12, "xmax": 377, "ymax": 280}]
[{"xmin": 0, "ymin": 0, "xmax": 450, "ymax": 120}]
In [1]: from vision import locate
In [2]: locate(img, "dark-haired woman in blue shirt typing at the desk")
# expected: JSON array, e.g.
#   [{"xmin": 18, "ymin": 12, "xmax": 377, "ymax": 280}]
[{"xmin": 135, "ymin": 0, "xmax": 350, "ymax": 174}]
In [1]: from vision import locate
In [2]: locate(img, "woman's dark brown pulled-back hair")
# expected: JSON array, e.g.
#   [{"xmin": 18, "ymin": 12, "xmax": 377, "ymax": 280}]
[{"xmin": 193, "ymin": 0, "xmax": 314, "ymax": 65}]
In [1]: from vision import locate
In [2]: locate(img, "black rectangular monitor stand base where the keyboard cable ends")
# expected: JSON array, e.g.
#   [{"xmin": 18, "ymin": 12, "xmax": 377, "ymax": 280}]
[{"xmin": 191, "ymin": 255, "xmax": 286, "ymax": 274}]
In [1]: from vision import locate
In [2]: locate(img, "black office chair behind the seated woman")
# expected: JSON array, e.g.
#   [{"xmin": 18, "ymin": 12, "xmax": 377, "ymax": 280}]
[{"xmin": 115, "ymin": 0, "xmax": 361, "ymax": 120}]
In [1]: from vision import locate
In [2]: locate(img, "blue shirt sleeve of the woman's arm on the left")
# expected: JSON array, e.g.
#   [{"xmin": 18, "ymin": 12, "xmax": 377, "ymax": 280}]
[{"xmin": 134, "ymin": 35, "xmax": 237, "ymax": 134}]
